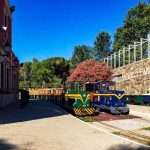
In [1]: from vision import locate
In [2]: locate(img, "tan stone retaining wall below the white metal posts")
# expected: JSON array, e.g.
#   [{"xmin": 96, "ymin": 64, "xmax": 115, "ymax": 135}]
[{"xmin": 113, "ymin": 59, "xmax": 150, "ymax": 94}]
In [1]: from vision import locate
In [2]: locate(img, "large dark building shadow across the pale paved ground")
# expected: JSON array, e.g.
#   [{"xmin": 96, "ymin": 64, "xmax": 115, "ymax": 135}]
[{"xmin": 0, "ymin": 100, "xmax": 68, "ymax": 124}]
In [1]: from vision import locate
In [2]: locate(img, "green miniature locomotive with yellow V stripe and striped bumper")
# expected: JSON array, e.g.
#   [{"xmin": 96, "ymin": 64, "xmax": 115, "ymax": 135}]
[{"xmin": 63, "ymin": 83, "xmax": 96, "ymax": 116}]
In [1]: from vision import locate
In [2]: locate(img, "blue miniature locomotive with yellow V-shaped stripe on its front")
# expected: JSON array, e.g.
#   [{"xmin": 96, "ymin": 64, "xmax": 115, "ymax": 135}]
[{"xmin": 88, "ymin": 81, "xmax": 129, "ymax": 114}]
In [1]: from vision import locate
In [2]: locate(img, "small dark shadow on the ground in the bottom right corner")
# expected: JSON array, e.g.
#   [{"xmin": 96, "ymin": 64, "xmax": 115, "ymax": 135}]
[{"xmin": 108, "ymin": 144, "xmax": 150, "ymax": 150}]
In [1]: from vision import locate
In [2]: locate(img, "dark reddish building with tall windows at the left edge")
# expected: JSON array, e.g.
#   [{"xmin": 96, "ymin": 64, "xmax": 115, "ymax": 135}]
[{"xmin": 0, "ymin": 0, "xmax": 19, "ymax": 107}]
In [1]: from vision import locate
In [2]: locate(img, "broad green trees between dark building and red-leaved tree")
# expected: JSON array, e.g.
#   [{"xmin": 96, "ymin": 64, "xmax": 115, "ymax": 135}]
[{"xmin": 20, "ymin": 57, "xmax": 70, "ymax": 88}]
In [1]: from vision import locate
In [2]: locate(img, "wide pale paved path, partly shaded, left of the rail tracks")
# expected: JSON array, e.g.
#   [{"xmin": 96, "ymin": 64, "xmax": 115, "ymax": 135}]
[{"xmin": 0, "ymin": 102, "xmax": 148, "ymax": 150}]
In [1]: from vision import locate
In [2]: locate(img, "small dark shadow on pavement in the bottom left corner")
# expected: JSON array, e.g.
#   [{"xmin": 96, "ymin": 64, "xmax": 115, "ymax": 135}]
[{"xmin": 0, "ymin": 139, "xmax": 19, "ymax": 150}]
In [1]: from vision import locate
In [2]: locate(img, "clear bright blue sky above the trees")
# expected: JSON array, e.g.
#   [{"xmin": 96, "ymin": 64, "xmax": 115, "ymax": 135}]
[{"xmin": 11, "ymin": 0, "xmax": 139, "ymax": 62}]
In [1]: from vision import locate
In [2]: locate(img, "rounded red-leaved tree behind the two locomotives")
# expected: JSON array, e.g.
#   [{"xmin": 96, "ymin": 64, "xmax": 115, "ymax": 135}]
[{"xmin": 68, "ymin": 60, "xmax": 112, "ymax": 83}]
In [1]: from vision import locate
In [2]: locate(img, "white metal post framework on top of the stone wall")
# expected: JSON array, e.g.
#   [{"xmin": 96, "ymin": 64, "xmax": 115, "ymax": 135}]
[{"xmin": 103, "ymin": 33, "xmax": 150, "ymax": 68}]
